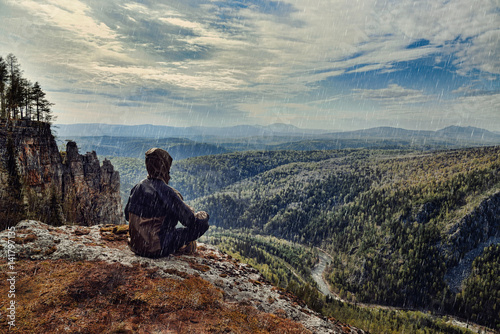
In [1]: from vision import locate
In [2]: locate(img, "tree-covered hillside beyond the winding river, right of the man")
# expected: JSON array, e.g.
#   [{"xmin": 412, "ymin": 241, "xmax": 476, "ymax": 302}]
[{"xmin": 113, "ymin": 147, "xmax": 500, "ymax": 327}]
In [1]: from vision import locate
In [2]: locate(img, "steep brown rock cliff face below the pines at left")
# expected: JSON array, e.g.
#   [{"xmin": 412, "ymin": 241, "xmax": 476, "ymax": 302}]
[{"xmin": 0, "ymin": 120, "xmax": 123, "ymax": 225}]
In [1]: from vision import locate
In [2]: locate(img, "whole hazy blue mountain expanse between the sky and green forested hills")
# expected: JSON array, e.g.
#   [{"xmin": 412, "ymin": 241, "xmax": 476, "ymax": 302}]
[{"xmin": 55, "ymin": 123, "xmax": 500, "ymax": 160}]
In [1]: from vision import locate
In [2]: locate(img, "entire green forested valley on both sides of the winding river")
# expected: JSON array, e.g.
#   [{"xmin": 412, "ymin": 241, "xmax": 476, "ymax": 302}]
[{"xmin": 108, "ymin": 147, "xmax": 500, "ymax": 333}]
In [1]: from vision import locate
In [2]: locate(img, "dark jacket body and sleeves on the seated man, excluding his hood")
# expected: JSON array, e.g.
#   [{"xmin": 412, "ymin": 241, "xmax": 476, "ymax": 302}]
[{"xmin": 125, "ymin": 178, "xmax": 197, "ymax": 257}]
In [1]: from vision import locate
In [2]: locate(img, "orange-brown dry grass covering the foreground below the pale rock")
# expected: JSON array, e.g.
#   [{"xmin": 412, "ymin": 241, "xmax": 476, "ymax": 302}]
[{"xmin": 0, "ymin": 260, "xmax": 309, "ymax": 333}]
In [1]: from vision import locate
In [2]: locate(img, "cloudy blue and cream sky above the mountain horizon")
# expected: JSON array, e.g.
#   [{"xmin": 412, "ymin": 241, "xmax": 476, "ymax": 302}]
[{"xmin": 0, "ymin": 0, "xmax": 500, "ymax": 131}]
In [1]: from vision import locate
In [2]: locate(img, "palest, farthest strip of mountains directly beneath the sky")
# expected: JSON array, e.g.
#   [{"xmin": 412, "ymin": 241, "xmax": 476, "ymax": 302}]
[{"xmin": 54, "ymin": 123, "xmax": 500, "ymax": 145}]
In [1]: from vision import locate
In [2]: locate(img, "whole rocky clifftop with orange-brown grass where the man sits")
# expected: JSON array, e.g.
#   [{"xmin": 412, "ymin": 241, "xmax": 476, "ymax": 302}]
[{"xmin": 0, "ymin": 221, "xmax": 363, "ymax": 333}]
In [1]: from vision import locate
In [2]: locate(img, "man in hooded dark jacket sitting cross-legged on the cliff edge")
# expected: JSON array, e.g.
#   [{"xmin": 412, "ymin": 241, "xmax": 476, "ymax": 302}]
[{"xmin": 125, "ymin": 148, "xmax": 209, "ymax": 258}]
